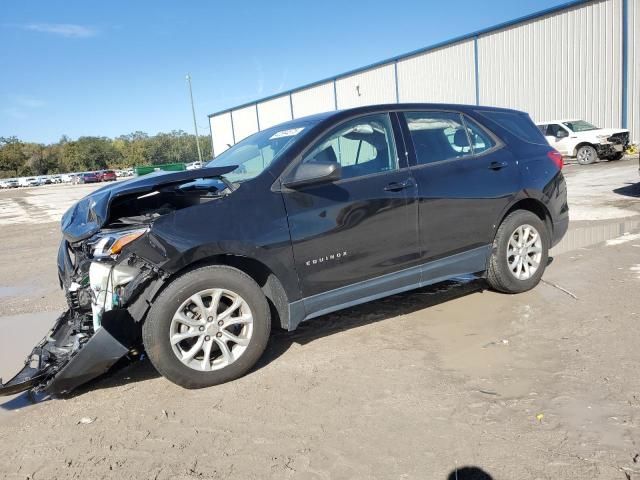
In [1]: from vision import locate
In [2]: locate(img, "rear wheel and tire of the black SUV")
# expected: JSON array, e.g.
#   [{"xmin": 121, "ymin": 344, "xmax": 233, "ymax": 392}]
[{"xmin": 487, "ymin": 210, "xmax": 550, "ymax": 293}]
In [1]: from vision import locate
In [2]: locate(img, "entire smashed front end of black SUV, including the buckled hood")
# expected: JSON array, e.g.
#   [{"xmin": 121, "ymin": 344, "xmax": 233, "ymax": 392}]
[{"xmin": 0, "ymin": 167, "xmax": 232, "ymax": 396}]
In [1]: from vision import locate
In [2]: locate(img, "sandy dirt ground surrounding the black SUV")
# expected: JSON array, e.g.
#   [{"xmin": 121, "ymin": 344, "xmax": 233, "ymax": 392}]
[{"xmin": 0, "ymin": 159, "xmax": 640, "ymax": 480}]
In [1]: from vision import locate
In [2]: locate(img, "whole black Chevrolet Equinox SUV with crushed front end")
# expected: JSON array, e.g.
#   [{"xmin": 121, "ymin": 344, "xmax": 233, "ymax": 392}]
[{"xmin": 0, "ymin": 104, "xmax": 568, "ymax": 394}]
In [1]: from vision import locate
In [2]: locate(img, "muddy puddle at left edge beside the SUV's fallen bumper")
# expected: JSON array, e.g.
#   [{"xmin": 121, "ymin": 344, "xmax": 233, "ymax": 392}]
[{"xmin": 0, "ymin": 312, "xmax": 57, "ymax": 420}]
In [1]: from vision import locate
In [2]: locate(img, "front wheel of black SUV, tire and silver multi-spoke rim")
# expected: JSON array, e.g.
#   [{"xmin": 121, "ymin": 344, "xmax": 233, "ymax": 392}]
[{"xmin": 142, "ymin": 266, "xmax": 271, "ymax": 388}]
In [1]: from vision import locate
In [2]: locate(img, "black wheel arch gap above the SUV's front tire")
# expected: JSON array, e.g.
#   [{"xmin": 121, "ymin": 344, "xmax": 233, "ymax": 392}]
[{"xmin": 158, "ymin": 254, "xmax": 289, "ymax": 329}]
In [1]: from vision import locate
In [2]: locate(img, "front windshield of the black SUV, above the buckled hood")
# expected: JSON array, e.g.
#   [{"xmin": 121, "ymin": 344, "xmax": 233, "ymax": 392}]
[{"xmin": 205, "ymin": 120, "xmax": 314, "ymax": 182}]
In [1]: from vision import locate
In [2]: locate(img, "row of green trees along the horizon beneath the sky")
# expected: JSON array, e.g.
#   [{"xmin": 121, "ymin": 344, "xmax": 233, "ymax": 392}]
[{"xmin": 0, "ymin": 130, "xmax": 211, "ymax": 178}]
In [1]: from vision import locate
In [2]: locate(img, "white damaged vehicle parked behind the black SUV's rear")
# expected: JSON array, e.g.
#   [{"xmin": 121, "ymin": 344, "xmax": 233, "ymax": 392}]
[{"xmin": 536, "ymin": 119, "xmax": 629, "ymax": 165}]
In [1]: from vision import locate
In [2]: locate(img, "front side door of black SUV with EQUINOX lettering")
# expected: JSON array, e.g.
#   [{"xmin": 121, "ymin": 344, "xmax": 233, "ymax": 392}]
[{"xmin": 283, "ymin": 113, "xmax": 419, "ymax": 304}]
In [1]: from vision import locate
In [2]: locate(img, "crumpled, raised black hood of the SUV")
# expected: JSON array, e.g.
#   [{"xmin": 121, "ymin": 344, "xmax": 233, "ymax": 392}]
[{"xmin": 61, "ymin": 165, "xmax": 237, "ymax": 243}]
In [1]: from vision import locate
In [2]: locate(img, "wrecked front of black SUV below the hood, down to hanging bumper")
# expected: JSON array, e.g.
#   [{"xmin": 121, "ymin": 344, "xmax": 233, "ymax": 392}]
[{"xmin": 0, "ymin": 232, "xmax": 162, "ymax": 395}]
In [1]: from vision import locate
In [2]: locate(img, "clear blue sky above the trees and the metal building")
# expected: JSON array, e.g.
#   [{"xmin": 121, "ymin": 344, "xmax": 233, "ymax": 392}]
[{"xmin": 0, "ymin": 0, "xmax": 565, "ymax": 143}]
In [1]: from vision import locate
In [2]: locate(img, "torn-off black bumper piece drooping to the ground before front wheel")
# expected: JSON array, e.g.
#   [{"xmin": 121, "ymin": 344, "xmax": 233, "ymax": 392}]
[{"xmin": 0, "ymin": 311, "xmax": 129, "ymax": 396}]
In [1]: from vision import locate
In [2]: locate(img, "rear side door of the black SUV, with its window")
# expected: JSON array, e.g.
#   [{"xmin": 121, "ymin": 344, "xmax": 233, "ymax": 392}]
[{"xmin": 402, "ymin": 111, "xmax": 519, "ymax": 261}]
